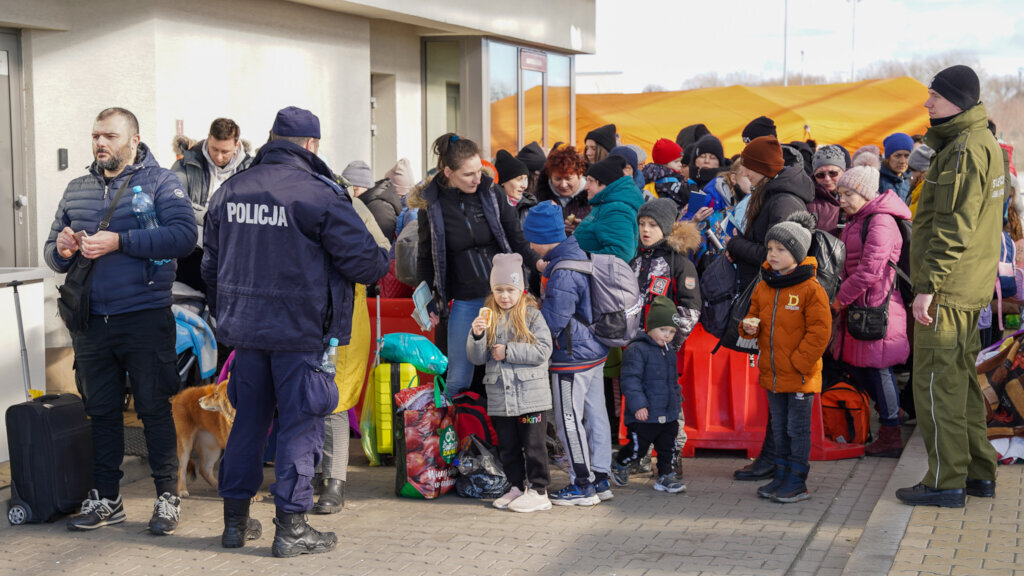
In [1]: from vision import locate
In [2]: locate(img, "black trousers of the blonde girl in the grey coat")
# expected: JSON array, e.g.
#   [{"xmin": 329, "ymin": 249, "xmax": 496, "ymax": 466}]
[{"xmin": 490, "ymin": 412, "xmax": 551, "ymax": 494}]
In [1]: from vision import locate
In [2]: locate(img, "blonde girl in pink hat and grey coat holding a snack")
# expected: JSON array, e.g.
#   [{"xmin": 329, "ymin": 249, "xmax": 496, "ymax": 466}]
[{"xmin": 466, "ymin": 254, "xmax": 551, "ymax": 512}]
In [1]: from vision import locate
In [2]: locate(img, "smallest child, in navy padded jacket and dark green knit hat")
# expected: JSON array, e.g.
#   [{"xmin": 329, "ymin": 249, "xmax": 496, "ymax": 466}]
[{"xmin": 612, "ymin": 296, "xmax": 686, "ymax": 494}]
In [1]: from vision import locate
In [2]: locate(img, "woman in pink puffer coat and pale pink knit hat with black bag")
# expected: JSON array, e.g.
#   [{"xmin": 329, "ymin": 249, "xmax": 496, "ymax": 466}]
[{"xmin": 836, "ymin": 166, "xmax": 910, "ymax": 457}]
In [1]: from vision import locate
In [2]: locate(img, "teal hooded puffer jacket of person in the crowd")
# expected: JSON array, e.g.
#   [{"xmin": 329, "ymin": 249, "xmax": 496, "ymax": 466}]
[{"xmin": 574, "ymin": 176, "xmax": 644, "ymax": 262}]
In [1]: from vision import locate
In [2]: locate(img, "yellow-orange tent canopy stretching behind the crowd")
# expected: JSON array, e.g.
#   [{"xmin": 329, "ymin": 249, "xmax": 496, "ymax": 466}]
[{"xmin": 577, "ymin": 77, "xmax": 929, "ymax": 156}]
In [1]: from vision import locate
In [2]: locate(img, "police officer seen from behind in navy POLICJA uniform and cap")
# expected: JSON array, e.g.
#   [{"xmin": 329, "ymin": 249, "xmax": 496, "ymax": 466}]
[{"xmin": 202, "ymin": 107, "xmax": 388, "ymax": 558}]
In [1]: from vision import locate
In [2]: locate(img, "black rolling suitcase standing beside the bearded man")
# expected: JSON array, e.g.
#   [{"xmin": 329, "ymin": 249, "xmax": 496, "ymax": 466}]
[{"xmin": 6, "ymin": 394, "xmax": 92, "ymax": 525}]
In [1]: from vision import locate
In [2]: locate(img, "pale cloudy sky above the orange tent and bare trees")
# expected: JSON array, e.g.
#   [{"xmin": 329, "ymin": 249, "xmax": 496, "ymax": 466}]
[{"xmin": 577, "ymin": 0, "xmax": 1024, "ymax": 92}]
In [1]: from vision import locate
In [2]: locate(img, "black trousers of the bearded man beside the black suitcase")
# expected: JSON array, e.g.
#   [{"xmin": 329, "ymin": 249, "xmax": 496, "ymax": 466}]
[{"xmin": 72, "ymin": 307, "xmax": 179, "ymax": 498}]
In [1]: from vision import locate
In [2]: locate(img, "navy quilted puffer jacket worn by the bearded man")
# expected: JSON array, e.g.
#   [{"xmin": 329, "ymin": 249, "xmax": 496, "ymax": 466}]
[{"xmin": 43, "ymin": 142, "xmax": 198, "ymax": 316}]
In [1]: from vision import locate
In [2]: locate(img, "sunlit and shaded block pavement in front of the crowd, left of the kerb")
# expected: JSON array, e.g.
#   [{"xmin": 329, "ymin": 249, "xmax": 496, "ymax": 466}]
[{"xmin": 0, "ymin": 443, "xmax": 897, "ymax": 576}]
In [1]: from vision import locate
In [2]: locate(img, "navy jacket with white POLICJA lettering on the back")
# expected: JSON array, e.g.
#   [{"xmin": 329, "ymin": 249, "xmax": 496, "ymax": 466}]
[{"xmin": 201, "ymin": 140, "xmax": 388, "ymax": 352}]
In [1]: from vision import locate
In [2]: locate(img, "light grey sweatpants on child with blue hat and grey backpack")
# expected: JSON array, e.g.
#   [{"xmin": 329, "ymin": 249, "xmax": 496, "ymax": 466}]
[{"xmin": 551, "ymin": 362, "xmax": 611, "ymax": 485}]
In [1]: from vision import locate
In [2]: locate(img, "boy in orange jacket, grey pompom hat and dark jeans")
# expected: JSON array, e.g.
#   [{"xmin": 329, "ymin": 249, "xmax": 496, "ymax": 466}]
[{"xmin": 739, "ymin": 212, "xmax": 831, "ymax": 502}]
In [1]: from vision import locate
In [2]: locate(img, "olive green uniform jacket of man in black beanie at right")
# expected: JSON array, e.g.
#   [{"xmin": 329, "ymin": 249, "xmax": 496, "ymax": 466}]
[{"xmin": 910, "ymin": 104, "xmax": 1007, "ymax": 312}]
